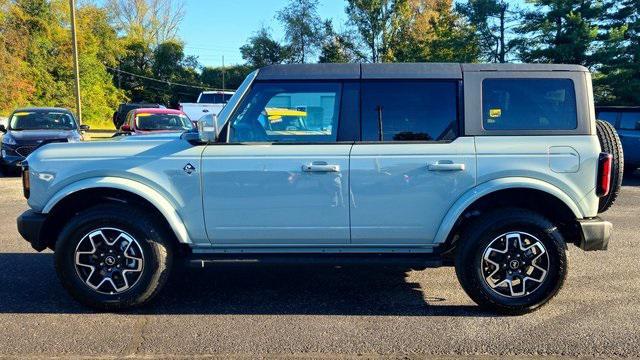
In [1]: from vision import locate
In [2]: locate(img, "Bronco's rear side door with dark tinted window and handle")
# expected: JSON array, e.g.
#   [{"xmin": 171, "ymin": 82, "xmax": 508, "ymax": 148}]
[{"xmin": 351, "ymin": 79, "xmax": 476, "ymax": 246}]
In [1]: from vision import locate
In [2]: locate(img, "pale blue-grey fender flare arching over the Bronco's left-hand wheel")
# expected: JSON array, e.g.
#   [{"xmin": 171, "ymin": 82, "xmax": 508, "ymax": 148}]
[{"xmin": 42, "ymin": 177, "xmax": 192, "ymax": 244}]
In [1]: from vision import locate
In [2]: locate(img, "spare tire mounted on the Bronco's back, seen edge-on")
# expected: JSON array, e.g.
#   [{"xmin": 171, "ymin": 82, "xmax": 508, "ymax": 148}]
[{"xmin": 596, "ymin": 120, "xmax": 624, "ymax": 213}]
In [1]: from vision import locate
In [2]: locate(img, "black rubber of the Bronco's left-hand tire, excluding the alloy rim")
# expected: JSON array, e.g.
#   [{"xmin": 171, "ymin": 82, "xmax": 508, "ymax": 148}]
[{"xmin": 55, "ymin": 204, "xmax": 174, "ymax": 311}]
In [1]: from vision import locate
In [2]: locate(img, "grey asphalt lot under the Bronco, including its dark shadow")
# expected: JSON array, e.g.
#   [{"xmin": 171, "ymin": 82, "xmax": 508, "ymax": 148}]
[{"xmin": 0, "ymin": 176, "xmax": 640, "ymax": 358}]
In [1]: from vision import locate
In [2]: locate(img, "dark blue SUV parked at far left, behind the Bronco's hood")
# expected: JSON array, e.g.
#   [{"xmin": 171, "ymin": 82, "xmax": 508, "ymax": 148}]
[{"xmin": 0, "ymin": 108, "xmax": 89, "ymax": 174}]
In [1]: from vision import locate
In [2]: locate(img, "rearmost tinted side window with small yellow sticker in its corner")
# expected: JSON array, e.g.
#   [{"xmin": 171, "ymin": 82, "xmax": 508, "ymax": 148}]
[{"xmin": 482, "ymin": 79, "xmax": 578, "ymax": 130}]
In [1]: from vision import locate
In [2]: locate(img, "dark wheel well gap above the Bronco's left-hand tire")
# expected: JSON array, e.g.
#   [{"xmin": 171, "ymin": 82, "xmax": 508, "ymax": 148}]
[{"xmin": 41, "ymin": 187, "xmax": 185, "ymax": 250}]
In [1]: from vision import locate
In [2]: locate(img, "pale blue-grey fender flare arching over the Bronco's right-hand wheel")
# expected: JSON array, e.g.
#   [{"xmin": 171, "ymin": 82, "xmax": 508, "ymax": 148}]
[{"xmin": 434, "ymin": 177, "xmax": 584, "ymax": 244}]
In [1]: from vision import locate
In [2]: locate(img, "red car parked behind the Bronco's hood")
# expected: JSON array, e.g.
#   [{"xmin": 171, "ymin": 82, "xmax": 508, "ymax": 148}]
[{"xmin": 120, "ymin": 108, "xmax": 195, "ymax": 135}]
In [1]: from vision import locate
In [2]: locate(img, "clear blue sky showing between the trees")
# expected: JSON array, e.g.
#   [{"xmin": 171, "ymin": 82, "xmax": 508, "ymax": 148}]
[{"xmin": 178, "ymin": 0, "xmax": 346, "ymax": 66}]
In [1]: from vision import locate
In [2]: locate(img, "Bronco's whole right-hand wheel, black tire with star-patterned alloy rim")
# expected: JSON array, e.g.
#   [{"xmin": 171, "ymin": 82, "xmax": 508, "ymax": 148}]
[{"xmin": 455, "ymin": 208, "xmax": 567, "ymax": 315}]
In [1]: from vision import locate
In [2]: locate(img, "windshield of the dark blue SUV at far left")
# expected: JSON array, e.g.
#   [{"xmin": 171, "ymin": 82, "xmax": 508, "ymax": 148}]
[{"xmin": 9, "ymin": 110, "xmax": 76, "ymax": 130}]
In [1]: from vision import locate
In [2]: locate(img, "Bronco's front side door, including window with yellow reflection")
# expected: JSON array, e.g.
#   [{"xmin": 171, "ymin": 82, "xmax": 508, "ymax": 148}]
[{"xmin": 202, "ymin": 82, "xmax": 352, "ymax": 247}]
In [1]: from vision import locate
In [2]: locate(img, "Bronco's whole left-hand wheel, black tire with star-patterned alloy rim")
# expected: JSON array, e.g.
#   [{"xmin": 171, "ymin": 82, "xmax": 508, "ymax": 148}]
[{"xmin": 55, "ymin": 204, "xmax": 174, "ymax": 311}]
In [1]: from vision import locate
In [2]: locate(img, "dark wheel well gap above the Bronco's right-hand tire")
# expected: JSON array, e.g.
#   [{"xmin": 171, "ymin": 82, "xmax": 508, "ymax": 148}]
[{"xmin": 443, "ymin": 188, "xmax": 579, "ymax": 255}]
